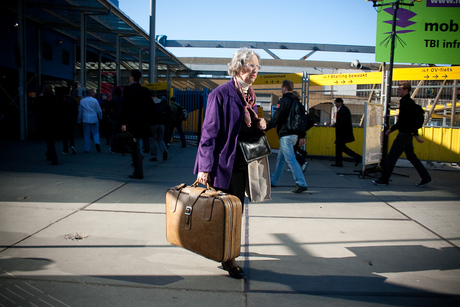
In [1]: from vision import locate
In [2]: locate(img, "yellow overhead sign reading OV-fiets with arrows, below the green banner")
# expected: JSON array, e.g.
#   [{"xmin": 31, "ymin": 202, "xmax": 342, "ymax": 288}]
[{"xmin": 393, "ymin": 66, "xmax": 460, "ymax": 81}]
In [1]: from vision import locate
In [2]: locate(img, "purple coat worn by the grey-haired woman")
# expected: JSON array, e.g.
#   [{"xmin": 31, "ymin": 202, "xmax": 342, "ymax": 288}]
[{"xmin": 194, "ymin": 79, "xmax": 257, "ymax": 189}]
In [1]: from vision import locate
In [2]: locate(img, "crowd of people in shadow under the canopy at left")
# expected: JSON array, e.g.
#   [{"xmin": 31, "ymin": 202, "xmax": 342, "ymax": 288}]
[{"xmin": 33, "ymin": 70, "xmax": 186, "ymax": 171}]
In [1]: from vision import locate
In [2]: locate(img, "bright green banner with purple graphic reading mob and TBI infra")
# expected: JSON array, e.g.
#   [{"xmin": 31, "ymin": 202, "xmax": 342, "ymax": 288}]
[{"xmin": 375, "ymin": 0, "xmax": 460, "ymax": 64}]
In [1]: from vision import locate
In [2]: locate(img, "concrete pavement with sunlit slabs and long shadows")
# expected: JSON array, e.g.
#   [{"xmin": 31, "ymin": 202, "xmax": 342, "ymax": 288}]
[{"xmin": 0, "ymin": 139, "xmax": 460, "ymax": 306}]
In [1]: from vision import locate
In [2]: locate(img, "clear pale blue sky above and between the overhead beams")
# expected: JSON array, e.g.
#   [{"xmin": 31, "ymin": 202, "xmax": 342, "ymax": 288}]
[{"xmin": 119, "ymin": 0, "xmax": 377, "ymax": 63}]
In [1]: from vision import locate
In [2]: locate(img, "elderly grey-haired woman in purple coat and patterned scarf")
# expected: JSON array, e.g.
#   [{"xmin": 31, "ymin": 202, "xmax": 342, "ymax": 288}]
[{"xmin": 195, "ymin": 48, "xmax": 270, "ymax": 279}]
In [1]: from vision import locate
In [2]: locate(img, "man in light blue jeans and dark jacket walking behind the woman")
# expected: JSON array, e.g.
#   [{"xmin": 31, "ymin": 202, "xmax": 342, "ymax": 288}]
[{"xmin": 267, "ymin": 80, "xmax": 308, "ymax": 193}]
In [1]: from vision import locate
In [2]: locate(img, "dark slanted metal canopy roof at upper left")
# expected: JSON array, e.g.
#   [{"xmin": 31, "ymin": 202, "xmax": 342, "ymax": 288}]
[{"xmin": 4, "ymin": 0, "xmax": 189, "ymax": 73}]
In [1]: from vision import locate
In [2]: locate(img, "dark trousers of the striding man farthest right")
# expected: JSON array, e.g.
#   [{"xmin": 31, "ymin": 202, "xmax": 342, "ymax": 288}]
[{"xmin": 380, "ymin": 133, "xmax": 431, "ymax": 182}]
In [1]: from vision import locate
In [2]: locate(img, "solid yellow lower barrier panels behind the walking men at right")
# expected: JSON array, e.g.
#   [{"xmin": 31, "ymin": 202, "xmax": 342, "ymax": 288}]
[{"xmin": 267, "ymin": 126, "xmax": 460, "ymax": 163}]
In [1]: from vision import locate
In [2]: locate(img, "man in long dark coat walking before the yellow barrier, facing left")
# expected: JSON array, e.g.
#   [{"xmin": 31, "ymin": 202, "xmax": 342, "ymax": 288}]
[{"xmin": 332, "ymin": 98, "xmax": 362, "ymax": 167}]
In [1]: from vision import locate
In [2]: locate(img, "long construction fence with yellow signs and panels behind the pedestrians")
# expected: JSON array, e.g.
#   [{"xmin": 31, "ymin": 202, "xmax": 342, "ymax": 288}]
[{"xmin": 174, "ymin": 67, "xmax": 460, "ymax": 162}]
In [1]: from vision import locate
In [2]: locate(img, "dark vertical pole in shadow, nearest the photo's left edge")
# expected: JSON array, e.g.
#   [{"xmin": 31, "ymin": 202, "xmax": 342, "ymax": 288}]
[{"xmin": 18, "ymin": 0, "xmax": 27, "ymax": 141}]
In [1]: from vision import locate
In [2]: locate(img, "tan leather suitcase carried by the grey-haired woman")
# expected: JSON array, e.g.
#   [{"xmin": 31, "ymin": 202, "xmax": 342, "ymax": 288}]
[{"xmin": 166, "ymin": 182, "xmax": 242, "ymax": 262}]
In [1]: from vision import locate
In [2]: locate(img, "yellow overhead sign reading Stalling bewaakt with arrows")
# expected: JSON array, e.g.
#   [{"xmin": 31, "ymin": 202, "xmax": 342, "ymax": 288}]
[{"xmin": 309, "ymin": 72, "xmax": 382, "ymax": 86}]
